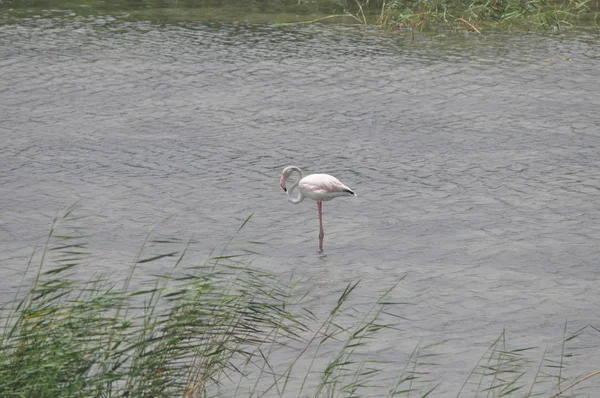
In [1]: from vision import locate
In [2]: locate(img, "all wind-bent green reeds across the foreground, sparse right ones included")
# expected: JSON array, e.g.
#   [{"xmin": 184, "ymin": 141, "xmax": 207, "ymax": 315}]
[{"xmin": 0, "ymin": 207, "xmax": 600, "ymax": 398}]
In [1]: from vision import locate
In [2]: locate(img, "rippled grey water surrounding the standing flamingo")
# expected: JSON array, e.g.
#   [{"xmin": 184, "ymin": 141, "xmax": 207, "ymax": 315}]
[{"xmin": 0, "ymin": 9, "xmax": 600, "ymax": 396}]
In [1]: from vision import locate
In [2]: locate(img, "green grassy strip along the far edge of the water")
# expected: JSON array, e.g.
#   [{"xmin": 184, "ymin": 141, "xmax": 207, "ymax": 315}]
[{"xmin": 0, "ymin": 0, "xmax": 600, "ymax": 34}]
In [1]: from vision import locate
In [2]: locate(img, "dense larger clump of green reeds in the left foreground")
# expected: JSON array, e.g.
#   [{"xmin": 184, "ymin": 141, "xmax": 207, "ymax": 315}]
[{"xmin": 0, "ymin": 207, "xmax": 432, "ymax": 397}]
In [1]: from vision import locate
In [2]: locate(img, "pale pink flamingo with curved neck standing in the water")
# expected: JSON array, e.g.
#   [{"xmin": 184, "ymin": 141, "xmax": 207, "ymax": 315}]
[{"xmin": 281, "ymin": 166, "xmax": 357, "ymax": 253}]
